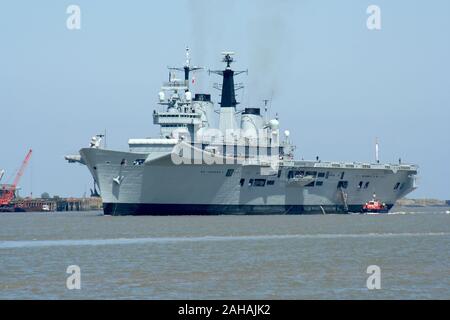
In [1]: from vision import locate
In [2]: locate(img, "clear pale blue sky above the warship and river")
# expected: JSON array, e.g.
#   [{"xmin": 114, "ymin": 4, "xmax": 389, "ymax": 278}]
[{"xmin": 0, "ymin": 0, "xmax": 450, "ymax": 199}]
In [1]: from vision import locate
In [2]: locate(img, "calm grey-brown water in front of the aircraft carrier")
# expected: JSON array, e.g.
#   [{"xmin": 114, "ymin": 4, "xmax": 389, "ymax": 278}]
[{"xmin": 0, "ymin": 208, "xmax": 450, "ymax": 299}]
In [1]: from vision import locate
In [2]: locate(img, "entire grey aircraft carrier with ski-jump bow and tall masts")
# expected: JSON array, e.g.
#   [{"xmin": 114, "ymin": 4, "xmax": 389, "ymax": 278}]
[{"xmin": 65, "ymin": 49, "xmax": 417, "ymax": 215}]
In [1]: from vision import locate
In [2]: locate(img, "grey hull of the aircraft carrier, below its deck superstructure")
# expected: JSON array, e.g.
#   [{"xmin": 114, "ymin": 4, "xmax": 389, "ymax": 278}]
[{"xmin": 80, "ymin": 148, "xmax": 417, "ymax": 215}]
